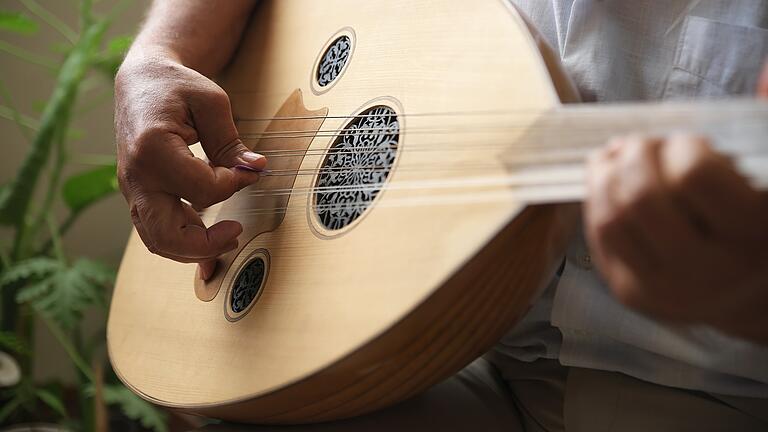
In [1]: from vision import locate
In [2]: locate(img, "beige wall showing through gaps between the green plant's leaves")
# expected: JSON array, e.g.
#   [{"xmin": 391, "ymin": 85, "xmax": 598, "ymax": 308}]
[{"xmin": 0, "ymin": 0, "xmax": 150, "ymax": 379}]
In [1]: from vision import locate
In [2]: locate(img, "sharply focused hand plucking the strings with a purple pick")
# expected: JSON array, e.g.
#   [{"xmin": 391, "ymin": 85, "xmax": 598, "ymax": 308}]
[{"xmin": 115, "ymin": 56, "xmax": 266, "ymax": 279}]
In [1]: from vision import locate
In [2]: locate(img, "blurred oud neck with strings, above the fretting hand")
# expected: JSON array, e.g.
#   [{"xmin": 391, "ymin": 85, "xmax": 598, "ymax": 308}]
[{"xmin": 502, "ymin": 99, "xmax": 768, "ymax": 203}]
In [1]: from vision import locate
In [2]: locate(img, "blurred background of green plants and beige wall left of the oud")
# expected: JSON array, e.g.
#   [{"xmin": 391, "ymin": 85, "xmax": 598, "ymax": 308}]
[{"xmin": 0, "ymin": 0, "xmax": 195, "ymax": 431}]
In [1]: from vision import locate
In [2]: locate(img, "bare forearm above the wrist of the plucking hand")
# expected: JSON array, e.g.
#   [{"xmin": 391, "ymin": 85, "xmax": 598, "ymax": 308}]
[{"xmin": 126, "ymin": 0, "xmax": 256, "ymax": 77}]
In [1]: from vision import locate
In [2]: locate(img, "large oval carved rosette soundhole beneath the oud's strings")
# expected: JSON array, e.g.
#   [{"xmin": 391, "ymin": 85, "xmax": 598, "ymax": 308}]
[{"xmin": 314, "ymin": 105, "xmax": 400, "ymax": 230}]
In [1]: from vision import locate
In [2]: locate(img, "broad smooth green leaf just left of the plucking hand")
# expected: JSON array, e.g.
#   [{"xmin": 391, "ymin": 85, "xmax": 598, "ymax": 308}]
[{"xmin": 62, "ymin": 164, "xmax": 118, "ymax": 212}]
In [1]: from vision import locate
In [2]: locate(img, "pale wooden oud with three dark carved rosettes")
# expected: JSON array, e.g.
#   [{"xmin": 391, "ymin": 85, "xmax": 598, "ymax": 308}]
[{"xmin": 108, "ymin": 0, "xmax": 766, "ymax": 423}]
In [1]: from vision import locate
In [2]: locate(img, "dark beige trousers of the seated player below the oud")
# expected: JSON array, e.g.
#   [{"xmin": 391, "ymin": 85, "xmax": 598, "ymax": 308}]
[{"xmin": 196, "ymin": 354, "xmax": 768, "ymax": 432}]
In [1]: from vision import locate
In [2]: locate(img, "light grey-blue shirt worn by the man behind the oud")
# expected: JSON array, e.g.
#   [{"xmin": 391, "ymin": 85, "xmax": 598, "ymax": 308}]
[{"xmin": 496, "ymin": 0, "xmax": 768, "ymax": 398}]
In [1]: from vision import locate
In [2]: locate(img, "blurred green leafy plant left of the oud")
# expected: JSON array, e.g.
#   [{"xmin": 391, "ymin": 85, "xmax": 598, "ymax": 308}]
[{"xmin": 0, "ymin": 0, "xmax": 166, "ymax": 432}]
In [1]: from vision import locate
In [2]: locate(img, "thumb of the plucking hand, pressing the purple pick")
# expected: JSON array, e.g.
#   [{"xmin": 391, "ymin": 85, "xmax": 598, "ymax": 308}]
[{"xmin": 190, "ymin": 83, "xmax": 267, "ymax": 172}]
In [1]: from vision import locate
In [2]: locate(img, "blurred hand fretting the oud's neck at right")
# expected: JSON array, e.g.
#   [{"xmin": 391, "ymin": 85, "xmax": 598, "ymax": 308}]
[{"xmin": 585, "ymin": 135, "xmax": 768, "ymax": 343}]
